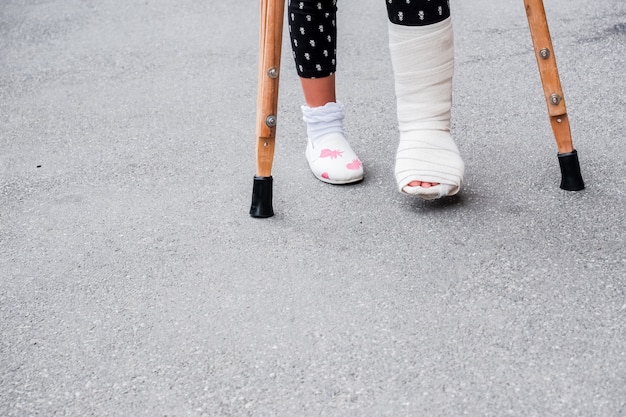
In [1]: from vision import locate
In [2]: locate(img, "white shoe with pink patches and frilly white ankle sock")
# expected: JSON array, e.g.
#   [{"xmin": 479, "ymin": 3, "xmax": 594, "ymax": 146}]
[{"xmin": 302, "ymin": 102, "xmax": 363, "ymax": 184}]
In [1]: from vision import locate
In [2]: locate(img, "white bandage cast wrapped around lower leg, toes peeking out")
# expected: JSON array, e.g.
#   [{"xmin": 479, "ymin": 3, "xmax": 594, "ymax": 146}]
[{"xmin": 389, "ymin": 18, "xmax": 464, "ymax": 200}]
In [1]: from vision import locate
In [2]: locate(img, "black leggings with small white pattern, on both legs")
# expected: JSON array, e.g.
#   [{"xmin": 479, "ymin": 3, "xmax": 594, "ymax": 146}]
[{"xmin": 287, "ymin": 0, "xmax": 450, "ymax": 78}]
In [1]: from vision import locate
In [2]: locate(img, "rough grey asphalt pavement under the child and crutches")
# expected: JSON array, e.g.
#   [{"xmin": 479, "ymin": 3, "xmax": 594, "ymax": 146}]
[{"xmin": 0, "ymin": 0, "xmax": 626, "ymax": 416}]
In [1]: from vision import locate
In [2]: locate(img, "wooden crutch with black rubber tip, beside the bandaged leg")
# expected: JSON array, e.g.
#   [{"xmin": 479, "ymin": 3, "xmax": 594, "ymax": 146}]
[{"xmin": 524, "ymin": 0, "xmax": 585, "ymax": 191}]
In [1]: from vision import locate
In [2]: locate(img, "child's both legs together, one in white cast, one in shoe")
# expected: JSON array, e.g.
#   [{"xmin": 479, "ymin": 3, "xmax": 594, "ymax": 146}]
[{"xmin": 288, "ymin": 0, "xmax": 463, "ymax": 199}]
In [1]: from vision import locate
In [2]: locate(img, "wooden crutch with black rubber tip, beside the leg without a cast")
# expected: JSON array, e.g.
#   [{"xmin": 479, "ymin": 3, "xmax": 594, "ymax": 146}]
[{"xmin": 250, "ymin": 0, "xmax": 285, "ymax": 218}]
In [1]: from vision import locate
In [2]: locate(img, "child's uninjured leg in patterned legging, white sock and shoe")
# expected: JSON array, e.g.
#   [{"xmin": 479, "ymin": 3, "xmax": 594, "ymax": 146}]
[{"xmin": 287, "ymin": 0, "xmax": 363, "ymax": 184}]
